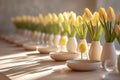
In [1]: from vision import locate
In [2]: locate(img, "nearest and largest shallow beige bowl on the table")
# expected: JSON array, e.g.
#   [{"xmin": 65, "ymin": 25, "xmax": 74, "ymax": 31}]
[{"xmin": 66, "ymin": 60, "xmax": 101, "ymax": 71}]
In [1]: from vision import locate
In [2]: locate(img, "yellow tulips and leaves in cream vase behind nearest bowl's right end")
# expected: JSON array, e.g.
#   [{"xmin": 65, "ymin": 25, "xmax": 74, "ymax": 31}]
[{"xmin": 86, "ymin": 12, "xmax": 102, "ymax": 41}]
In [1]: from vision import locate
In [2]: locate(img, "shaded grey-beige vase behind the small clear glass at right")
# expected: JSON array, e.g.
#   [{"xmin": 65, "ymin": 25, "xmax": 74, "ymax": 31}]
[{"xmin": 101, "ymin": 42, "xmax": 117, "ymax": 67}]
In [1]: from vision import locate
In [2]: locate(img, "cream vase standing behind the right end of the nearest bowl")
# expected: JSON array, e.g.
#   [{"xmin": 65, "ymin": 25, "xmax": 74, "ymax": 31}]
[{"xmin": 89, "ymin": 41, "xmax": 102, "ymax": 61}]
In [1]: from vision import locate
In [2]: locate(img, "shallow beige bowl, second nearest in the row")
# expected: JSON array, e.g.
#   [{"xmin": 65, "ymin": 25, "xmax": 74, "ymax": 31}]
[{"xmin": 50, "ymin": 52, "xmax": 79, "ymax": 61}]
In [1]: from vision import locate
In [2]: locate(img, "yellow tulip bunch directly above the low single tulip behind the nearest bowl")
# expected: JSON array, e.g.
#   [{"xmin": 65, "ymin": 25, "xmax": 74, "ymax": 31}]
[{"xmin": 74, "ymin": 8, "xmax": 88, "ymax": 39}]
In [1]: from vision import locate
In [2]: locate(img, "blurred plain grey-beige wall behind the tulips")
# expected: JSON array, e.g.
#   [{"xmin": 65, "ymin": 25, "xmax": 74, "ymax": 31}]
[{"xmin": 0, "ymin": 0, "xmax": 120, "ymax": 49}]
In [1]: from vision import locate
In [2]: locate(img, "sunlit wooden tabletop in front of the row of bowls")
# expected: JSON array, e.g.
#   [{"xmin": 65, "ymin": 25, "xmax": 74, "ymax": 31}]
[{"xmin": 0, "ymin": 36, "xmax": 119, "ymax": 80}]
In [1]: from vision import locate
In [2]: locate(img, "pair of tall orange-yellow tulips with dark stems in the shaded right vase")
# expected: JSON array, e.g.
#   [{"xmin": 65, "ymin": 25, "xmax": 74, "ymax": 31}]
[{"xmin": 99, "ymin": 7, "xmax": 116, "ymax": 42}]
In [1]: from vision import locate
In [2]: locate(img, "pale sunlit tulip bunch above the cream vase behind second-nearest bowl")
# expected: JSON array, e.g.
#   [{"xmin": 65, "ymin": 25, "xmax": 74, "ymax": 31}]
[{"xmin": 61, "ymin": 11, "xmax": 76, "ymax": 37}]
